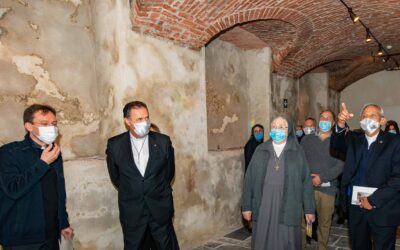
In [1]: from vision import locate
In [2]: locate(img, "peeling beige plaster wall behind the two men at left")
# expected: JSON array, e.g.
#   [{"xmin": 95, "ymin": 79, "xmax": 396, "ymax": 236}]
[{"xmin": 0, "ymin": 0, "xmax": 243, "ymax": 250}]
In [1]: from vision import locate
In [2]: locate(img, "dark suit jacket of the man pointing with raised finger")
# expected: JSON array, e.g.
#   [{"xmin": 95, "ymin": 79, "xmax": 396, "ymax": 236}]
[{"xmin": 331, "ymin": 129, "xmax": 400, "ymax": 226}]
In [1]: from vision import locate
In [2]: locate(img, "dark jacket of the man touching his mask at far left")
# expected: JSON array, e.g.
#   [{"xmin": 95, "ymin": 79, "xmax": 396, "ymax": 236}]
[{"xmin": 0, "ymin": 135, "xmax": 69, "ymax": 246}]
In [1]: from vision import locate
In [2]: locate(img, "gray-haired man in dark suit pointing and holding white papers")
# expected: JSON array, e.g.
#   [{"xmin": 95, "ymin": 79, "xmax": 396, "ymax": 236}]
[{"xmin": 331, "ymin": 103, "xmax": 400, "ymax": 250}]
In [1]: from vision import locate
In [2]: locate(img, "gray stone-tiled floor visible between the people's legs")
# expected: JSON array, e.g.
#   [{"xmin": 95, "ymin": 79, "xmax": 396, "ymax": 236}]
[{"xmin": 194, "ymin": 219, "xmax": 400, "ymax": 250}]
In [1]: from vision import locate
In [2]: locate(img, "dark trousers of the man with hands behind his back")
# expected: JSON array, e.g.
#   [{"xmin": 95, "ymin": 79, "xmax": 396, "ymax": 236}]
[{"xmin": 122, "ymin": 209, "xmax": 179, "ymax": 250}]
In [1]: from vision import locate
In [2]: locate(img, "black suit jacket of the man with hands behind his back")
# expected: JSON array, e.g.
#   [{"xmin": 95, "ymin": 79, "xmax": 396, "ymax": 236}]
[{"xmin": 106, "ymin": 131, "xmax": 175, "ymax": 227}]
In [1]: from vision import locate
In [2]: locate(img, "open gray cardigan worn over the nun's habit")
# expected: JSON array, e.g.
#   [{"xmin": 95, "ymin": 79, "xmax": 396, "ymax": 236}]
[{"xmin": 242, "ymin": 138, "xmax": 315, "ymax": 226}]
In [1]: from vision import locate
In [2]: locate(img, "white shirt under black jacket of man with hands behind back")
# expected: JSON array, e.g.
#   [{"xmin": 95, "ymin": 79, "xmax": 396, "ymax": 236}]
[{"xmin": 129, "ymin": 133, "xmax": 149, "ymax": 177}]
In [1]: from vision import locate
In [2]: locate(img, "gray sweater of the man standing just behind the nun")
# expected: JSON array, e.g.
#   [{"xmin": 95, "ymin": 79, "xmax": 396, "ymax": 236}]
[{"xmin": 301, "ymin": 135, "xmax": 344, "ymax": 195}]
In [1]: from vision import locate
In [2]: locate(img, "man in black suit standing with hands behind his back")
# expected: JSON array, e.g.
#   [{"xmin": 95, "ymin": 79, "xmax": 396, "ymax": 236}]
[{"xmin": 106, "ymin": 101, "xmax": 179, "ymax": 250}]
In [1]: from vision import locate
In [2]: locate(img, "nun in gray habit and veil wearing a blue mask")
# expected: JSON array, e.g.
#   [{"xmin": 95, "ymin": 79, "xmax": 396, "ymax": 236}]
[{"xmin": 242, "ymin": 117, "xmax": 315, "ymax": 250}]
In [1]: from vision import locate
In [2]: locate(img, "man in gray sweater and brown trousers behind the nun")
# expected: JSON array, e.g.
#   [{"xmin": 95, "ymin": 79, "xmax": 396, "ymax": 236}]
[{"xmin": 301, "ymin": 110, "xmax": 344, "ymax": 250}]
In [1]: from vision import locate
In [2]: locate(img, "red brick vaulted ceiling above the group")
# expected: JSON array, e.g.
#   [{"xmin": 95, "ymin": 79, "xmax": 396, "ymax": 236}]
[{"xmin": 132, "ymin": 0, "xmax": 400, "ymax": 91}]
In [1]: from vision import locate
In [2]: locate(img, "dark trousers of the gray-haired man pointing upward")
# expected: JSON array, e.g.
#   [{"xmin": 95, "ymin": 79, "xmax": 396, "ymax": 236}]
[{"xmin": 349, "ymin": 205, "xmax": 397, "ymax": 250}]
